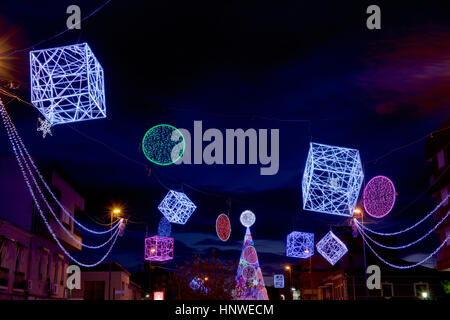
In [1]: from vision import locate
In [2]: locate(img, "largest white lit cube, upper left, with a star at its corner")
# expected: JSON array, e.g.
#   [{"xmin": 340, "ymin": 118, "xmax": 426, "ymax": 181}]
[{"xmin": 30, "ymin": 43, "xmax": 106, "ymax": 125}]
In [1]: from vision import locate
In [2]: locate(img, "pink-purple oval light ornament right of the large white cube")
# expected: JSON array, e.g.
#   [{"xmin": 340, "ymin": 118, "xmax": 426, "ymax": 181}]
[{"xmin": 363, "ymin": 176, "xmax": 395, "ymax": 218}]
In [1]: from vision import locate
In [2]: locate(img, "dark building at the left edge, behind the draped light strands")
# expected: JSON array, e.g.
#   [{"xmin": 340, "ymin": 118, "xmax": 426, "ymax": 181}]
[{"xmin": 0, "ymin": 158, "xmax": 84, "ymax": 300}]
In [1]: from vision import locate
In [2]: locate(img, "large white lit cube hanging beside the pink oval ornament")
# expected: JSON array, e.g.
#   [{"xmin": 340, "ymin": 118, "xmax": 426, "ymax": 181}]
[{"xmin": 302, "ymin": 143, "xmax": 364, "ymax": 217}]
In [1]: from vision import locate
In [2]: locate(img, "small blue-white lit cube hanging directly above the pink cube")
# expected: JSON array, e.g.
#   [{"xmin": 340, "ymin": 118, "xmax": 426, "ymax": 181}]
[{"xmin": 158, "ymin": 190, "xmax": 197, "ymax": 224}]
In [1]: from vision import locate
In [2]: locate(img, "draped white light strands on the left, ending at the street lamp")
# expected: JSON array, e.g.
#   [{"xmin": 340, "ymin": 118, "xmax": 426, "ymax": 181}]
[{"xmin": 0, "ymin": 100, "xmax": 123, "ymax": 267}]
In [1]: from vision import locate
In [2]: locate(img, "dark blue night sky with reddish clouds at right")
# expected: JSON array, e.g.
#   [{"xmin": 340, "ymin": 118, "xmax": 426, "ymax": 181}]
[{"xmin": 0, "ymin": 0, "xmax": 450, "ymax": 275}]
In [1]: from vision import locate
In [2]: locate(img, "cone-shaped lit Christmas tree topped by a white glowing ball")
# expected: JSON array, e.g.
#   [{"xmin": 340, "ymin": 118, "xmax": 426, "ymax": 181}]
[{"xmin": 233, "ymin": 211, "xmax": 269, "ymax": 300}]
